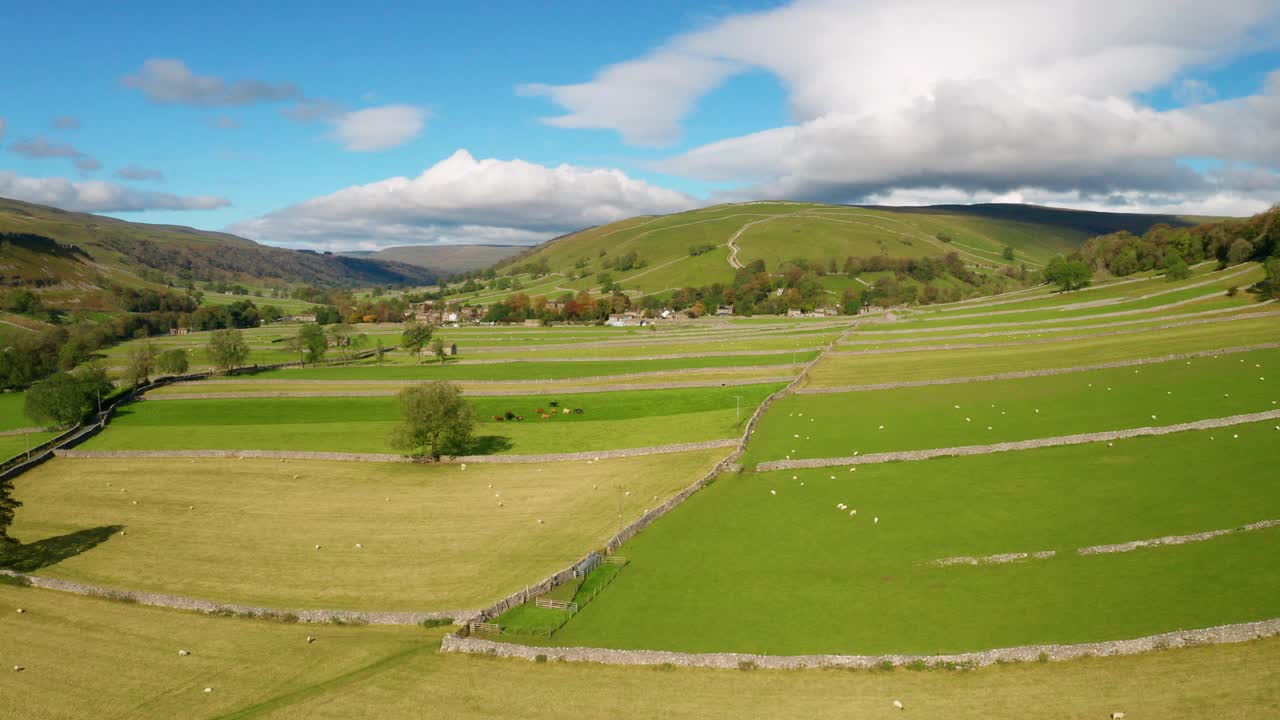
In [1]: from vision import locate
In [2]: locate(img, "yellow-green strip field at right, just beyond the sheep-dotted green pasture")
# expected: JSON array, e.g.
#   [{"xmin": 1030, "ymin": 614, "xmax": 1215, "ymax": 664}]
[{"xmin": 808, "ymin": 311, "xmax": 1280, "ymax": 387}]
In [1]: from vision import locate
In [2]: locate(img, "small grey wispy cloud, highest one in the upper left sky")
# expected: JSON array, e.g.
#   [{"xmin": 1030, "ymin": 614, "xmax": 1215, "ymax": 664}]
[{"xmin": 120, "ymin": 58, "xmax": 302, "ymax": 106}]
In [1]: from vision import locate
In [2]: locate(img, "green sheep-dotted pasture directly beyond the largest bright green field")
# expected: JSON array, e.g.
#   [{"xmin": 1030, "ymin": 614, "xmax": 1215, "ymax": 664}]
[{"xmin": 744, "ymin": 350, "xmax": 1280, "ymax": 466}]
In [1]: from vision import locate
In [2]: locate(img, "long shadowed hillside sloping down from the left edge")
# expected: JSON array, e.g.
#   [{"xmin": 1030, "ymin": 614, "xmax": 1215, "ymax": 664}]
[{"xmin": 0, "ymin": 199, "xmax": 439, "ymax": 297}]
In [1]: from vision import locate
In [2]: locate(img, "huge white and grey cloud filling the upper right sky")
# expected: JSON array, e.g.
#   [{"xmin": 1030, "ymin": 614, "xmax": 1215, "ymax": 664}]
[{"xmin": 524, "ymin": 0, "xmax": 1280, "ymax": 211}]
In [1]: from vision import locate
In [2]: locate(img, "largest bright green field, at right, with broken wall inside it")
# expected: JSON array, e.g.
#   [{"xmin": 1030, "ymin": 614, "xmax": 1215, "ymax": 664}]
[{"xmin": 552, "ymin": 423, "xmax": 1280, "ymax": 653}]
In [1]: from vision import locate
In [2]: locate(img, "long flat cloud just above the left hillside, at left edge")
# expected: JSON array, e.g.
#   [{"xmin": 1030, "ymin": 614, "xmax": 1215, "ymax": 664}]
[{"xmin": 0, "ymin": 170, "xmax": 230, "ymax": 213}]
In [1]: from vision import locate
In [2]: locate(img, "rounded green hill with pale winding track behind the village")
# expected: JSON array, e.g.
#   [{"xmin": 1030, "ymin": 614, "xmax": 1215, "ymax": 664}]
[{"xmin": 488, "ymin": 202, "xmax": 1193, "ymax": 293}]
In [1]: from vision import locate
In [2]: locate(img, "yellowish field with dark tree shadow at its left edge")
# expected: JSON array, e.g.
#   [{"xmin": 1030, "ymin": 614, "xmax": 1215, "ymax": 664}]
[{"xmin": 9, "ymin": 448, "xmax": 728, "ymax": 610}]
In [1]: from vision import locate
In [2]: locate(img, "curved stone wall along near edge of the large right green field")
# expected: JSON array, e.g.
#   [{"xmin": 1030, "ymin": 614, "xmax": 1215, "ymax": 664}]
[{"xmin": 440, "ymin": 619, "xmax": 1280, "ymax": 670}]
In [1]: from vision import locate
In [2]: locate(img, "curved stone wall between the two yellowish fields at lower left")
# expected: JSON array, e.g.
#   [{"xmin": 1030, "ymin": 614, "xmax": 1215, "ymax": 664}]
[{"xmin": 0, "ymin": 570, "xmax": 476, "ymax": 625}]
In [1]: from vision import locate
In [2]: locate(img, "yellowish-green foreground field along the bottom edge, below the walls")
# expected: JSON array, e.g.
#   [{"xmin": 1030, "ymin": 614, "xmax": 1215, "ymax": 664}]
[{"xmin": 0, "ymin": 585, "xmax": 1280, "ymax": 720}]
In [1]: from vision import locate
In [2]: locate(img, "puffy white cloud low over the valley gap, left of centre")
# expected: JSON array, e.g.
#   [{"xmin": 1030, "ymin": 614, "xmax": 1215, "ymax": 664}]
[{"xmin": 229, "ymin": 150, "xmax": 695, "ymax": 249}]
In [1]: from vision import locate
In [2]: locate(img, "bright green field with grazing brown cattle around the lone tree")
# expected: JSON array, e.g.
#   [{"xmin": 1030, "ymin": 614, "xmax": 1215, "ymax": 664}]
[{"xmin": 84, "ymin": 383, "xmax": 783, "ymax": 455}]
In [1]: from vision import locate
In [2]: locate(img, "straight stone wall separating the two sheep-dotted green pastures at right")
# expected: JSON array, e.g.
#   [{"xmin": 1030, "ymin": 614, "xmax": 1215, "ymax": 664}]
[{"xmin": 755, "ymin": 410, "xmax": 1280, "ymax": 473}]
